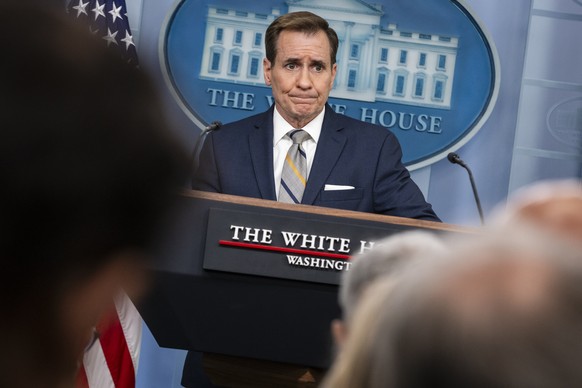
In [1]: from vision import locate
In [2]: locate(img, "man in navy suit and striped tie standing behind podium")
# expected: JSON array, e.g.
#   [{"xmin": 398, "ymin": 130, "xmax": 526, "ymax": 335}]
[{"xmin": 189, "ymin": 12, "xmax": 439, "ymax": 386}]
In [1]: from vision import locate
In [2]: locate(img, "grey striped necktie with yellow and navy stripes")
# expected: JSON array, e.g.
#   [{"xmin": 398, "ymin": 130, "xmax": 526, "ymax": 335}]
[{"xmin": 279, "ymin": 129, "xmax": 311, "ymax": 203}]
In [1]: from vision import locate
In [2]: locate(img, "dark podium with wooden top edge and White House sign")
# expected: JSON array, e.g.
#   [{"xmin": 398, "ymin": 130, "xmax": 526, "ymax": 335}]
[{"xmin": 138, "ymin": 191, "xmax": 467, "ymax": 384}]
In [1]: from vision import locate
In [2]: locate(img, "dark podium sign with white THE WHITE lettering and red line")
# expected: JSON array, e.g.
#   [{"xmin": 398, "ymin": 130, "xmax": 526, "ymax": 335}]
[{"xmin": 203, "ymin": 208, "xmax": 418, "ymax": 285}]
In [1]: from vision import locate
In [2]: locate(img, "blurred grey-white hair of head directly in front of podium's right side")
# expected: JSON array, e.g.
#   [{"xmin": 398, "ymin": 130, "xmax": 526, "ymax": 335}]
[{"xmin": 332, "ymin": 231, "xmax": 446, "ymax": 345}]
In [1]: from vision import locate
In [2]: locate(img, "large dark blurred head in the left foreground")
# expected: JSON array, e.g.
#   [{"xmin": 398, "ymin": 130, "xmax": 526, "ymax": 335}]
[{"xmin": 0, "ymin": 5, "xmax": 183, "ymax": 387}]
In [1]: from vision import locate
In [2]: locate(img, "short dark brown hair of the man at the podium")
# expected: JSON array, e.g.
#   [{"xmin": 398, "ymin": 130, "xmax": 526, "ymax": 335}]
[{"xmin": 265, "ymin": 11, "xmax": 339, "ymax": 65}]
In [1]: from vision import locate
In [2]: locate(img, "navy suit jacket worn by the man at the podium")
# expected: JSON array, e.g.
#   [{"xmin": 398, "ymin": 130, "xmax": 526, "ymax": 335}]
[{"xmin": 192, "ymin": 106, "xmax": 440, "ymax": 221}]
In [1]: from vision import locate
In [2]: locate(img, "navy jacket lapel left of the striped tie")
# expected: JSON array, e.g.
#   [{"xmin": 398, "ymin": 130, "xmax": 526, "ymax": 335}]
[{"xmin": 249, "ymin": 108, "xmax": 277, "ymax": 200}]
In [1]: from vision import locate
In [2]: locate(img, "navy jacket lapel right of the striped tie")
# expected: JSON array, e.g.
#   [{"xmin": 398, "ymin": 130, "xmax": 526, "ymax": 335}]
[{"xmin": 301, "ymin": 106, "xmax": 347, "ymax": 205}]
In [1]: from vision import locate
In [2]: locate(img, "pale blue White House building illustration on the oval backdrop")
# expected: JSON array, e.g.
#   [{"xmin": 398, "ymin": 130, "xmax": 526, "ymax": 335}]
[{"xmin": 200, "ymin": 0, "xmax": 459, "ymax": 109}]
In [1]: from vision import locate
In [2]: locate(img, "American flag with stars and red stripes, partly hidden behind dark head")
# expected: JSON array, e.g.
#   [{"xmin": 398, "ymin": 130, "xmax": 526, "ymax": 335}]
[{"xmin": 67, "ymin": 0, "xmax": 142, "ymax": 388}]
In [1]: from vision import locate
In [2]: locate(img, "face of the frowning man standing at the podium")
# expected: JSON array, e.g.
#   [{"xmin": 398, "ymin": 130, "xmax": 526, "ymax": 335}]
[{"xmin": 263, "ymin": 31, "xmax": 337, "ymax": 128}]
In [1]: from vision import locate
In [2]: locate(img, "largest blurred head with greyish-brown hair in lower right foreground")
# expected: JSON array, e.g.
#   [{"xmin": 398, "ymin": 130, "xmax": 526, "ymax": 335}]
[{"xmin": 323, "ymin": 230, "xmax": 582, "ymax": 388}]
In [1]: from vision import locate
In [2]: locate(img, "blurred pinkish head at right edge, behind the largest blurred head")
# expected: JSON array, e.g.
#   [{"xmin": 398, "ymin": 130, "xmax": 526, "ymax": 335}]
[{"xmin": 494, "ymin": 180, "xmax": 582, "ymax": 243}]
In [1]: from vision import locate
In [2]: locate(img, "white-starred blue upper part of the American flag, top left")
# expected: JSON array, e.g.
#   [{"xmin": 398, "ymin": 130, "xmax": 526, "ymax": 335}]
[{"xmin": 67, "ymin": 0, "xmax": 138, "ymax": 66}]
